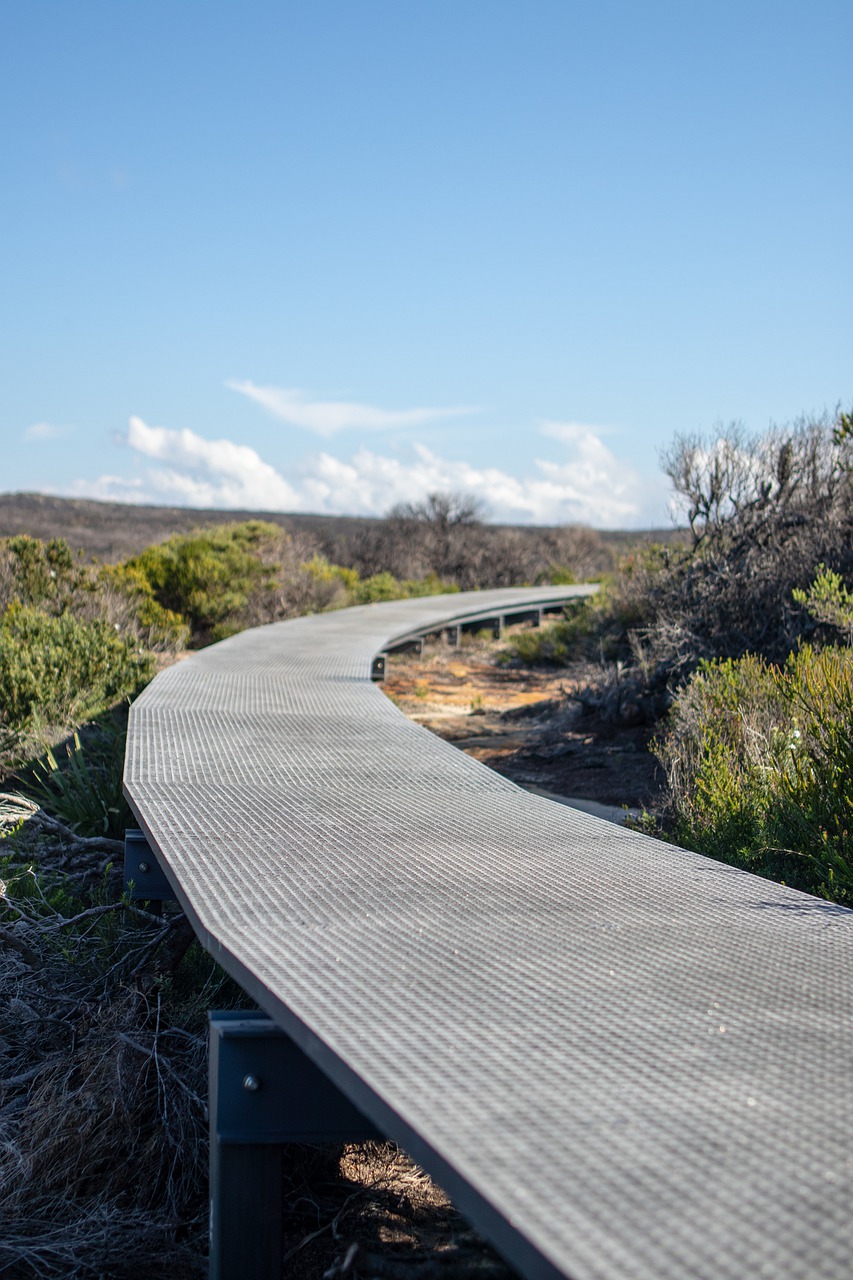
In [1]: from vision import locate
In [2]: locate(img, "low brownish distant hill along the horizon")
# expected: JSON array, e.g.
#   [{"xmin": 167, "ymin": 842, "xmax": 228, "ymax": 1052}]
[{"xmin": 0, "ymin": 493, "xmax": 684, "ymax": 561}]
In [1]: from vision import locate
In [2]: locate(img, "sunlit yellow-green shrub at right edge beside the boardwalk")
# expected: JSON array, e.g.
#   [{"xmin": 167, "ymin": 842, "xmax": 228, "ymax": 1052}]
[{"xmin": 657, "ymin": 646, "xmax": 853, "ymax": 902}]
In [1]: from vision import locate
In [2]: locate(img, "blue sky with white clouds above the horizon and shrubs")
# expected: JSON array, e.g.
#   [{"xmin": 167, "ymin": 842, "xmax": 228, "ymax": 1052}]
[{"xmin": 0, "ymin": 0, "xmax": 853, "ymax": 527}]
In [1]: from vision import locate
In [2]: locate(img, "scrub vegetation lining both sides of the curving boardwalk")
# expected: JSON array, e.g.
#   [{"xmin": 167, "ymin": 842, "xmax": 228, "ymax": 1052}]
[{"xmin": 0, "ymin": 413, "xmax": 853, "ymax": 1264}]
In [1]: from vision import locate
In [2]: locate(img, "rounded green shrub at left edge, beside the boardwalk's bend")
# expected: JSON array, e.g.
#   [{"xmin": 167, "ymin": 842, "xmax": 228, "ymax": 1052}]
[{"xmin": 0, "ymin": 604, "xmax": 154, "ymax": 737}]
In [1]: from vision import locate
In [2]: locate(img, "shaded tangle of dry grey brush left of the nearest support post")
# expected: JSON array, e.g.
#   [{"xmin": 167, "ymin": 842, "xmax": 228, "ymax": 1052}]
[{"xmin": 0, "ymin": 797, "xmax": 219, "ymax": 1280}]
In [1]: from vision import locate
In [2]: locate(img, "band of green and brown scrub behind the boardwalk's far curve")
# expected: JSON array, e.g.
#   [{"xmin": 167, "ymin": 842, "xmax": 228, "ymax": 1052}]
[{"xmin": 0, "ymin": 504, "xmax": 610, "ymax": 768}]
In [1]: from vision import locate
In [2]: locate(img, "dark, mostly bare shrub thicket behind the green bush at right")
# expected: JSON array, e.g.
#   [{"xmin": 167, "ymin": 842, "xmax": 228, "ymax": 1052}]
[{"xmin": 560, "ymin": 413, "xmax": 853, "ymax": 723}]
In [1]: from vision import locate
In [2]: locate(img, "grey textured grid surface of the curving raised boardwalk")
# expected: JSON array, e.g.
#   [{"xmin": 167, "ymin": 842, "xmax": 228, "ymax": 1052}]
[{"xmin": 126, "ymin": 589, "xmax": 853, "ymax": 1280}]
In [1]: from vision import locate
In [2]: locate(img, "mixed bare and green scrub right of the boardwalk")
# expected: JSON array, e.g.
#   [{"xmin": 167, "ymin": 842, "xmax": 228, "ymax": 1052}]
[{"xmin": 505, "ymin": 412, "xmax": 853, "ymax": 905}]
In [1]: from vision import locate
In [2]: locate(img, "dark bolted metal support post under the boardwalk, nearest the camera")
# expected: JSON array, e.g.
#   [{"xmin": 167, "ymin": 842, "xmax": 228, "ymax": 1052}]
[{"xmin": 209, "ymin": 1011, "xmax": 382, "ymax": 1280}]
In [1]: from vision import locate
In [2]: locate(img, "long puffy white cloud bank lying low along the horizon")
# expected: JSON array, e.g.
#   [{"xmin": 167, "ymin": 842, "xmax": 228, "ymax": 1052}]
[{"xmin": 73, "ymin": 417, "xmax": 667, "ymax": 529}]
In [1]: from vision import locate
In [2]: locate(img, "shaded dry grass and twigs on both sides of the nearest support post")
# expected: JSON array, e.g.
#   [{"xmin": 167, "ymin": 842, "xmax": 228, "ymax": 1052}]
[{"xmin": 0, "ymin": 795, "xmax": 512, "ymax": 1280}]
